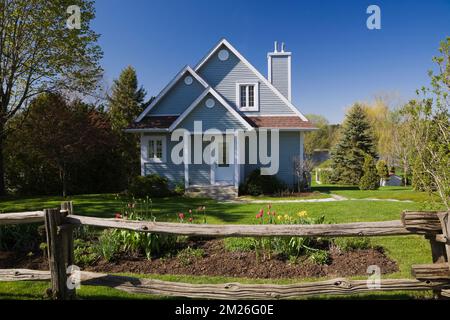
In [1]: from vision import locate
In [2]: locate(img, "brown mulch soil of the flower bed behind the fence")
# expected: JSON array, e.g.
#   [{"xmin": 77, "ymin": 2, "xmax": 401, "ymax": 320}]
[{"xmin": 0, "ymin": 239, "xmax": 398, "ymax": 279}]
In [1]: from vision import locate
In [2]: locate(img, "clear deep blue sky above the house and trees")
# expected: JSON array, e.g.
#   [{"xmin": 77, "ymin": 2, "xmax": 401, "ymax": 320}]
[{"xmin": 92, "ymin": 0, "xmax": 450, "ymax": 123}]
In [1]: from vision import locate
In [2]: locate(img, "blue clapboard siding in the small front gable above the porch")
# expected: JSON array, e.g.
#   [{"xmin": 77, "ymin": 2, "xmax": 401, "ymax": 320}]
[{"xmin": 177, "ymin": 94, "xmax": 244, "ymax": 132}]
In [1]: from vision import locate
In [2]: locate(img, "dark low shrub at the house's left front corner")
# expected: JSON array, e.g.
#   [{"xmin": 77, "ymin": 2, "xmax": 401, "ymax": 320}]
[{"xmin": 128, "ymin": 174, "xmax": 171, "ymax": 198}]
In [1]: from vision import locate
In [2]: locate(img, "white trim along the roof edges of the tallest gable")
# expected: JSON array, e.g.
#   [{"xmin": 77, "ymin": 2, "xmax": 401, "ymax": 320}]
[{"xmin": 194, "ymin": 39, "xmax": 308, "ymax": 121}]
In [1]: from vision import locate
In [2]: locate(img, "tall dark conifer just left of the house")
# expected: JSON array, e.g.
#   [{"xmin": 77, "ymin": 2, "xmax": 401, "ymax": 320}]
[{"xmin": 108, "ymin": 66, "xmax": 148, "ymax": 184}]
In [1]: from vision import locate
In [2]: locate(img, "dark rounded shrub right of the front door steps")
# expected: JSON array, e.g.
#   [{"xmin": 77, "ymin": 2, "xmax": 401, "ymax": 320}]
[{"xmin": 239, "ymin": 169, "xmax": 286, "ymax": 196}]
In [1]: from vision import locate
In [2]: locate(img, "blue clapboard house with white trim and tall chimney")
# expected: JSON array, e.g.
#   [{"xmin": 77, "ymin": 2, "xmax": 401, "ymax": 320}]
[{"xmin": 127, "ymin": 39, "xmax": 314, "ymax": 196}]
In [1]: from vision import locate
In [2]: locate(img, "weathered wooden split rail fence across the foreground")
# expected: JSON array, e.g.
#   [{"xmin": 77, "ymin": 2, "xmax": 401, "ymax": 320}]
[{"xmin": 0, "ymin": 202, "xmax": 450, "ymax": 299}]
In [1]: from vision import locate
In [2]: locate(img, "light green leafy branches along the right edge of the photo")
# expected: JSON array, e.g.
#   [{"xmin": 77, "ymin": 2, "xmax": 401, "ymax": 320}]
[{"xmin": 400, "ymin": 37, "xmax": 450, "ymax": 209}]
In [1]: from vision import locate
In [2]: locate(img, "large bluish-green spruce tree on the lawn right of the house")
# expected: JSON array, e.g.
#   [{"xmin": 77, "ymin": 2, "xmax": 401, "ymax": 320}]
[{"xmin": 331, "ymin": 104, "xmax": 376, "ymax": 185}]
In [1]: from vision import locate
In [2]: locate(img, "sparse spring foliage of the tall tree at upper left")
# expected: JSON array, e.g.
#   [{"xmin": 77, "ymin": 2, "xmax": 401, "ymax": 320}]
[{"xmin": 0, "ymin": 0, "xmax": 102, "ymax": 194}]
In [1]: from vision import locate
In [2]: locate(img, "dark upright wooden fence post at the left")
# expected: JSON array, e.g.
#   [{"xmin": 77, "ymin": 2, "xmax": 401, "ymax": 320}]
[{"xmin": 44, "ymin": 205, "xmax": 75, "ymax": 300}]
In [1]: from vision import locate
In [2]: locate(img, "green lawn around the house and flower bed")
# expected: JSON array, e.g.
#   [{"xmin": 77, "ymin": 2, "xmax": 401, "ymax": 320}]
[{"xmin": 0, "ymin": 186, "xmax": 442, "ymax": 299}]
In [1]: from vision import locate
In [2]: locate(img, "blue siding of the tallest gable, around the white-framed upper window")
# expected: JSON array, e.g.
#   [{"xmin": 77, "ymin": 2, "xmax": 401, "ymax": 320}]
[{"xmin": 198, "ymin": 44, "xmax": 295, "ymax": 116}]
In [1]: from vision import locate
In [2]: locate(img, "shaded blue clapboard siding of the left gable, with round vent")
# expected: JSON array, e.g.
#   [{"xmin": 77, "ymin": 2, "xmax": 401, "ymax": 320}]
[{"xmin": 148, "ymin": 73, "xmax": 205, "ymax": 115}]
